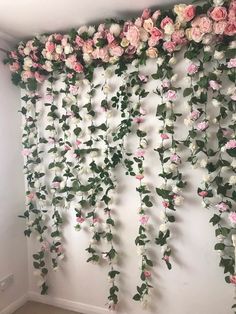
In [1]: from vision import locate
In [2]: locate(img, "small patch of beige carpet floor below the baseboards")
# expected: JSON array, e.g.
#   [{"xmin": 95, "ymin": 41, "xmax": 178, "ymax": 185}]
[{"xmin": 13, "ymin": 302, "xmax": 81, "ymax": 314}]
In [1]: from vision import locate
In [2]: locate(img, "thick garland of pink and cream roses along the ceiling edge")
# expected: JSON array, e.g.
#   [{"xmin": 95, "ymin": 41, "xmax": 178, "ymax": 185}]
[{"xmin": 8, "ymin": 0, "xmax": 236, "ymax": 86}]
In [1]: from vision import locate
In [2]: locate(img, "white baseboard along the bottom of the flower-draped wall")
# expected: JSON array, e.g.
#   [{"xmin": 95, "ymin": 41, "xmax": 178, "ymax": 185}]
[{"xmin": 27, "ymin": 292, "xmax": 111, "ymax": 314}]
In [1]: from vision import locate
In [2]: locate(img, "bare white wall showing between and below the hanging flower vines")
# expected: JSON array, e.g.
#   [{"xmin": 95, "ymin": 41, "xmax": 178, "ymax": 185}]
[{"xmin": 26, "ymin": 58, "xmax": 233, "ymax": 314}]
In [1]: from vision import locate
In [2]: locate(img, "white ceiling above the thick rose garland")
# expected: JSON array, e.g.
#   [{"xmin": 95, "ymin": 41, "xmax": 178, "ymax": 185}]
[{"xmin": 0, "ymin": 0, "xmax": 190, "ymax": 42}]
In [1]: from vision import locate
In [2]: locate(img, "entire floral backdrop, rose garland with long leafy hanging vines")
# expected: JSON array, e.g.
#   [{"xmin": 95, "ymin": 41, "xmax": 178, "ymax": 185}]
[{"xmin": 5, "ymin": 1, "xmax": 236, "ymax": 309}]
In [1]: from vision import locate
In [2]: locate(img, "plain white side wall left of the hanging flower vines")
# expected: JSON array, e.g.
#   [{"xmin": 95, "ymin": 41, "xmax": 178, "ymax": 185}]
[{"xmin": 0, "ymin": 39, "xmax": 28, "ymax": 312}]
